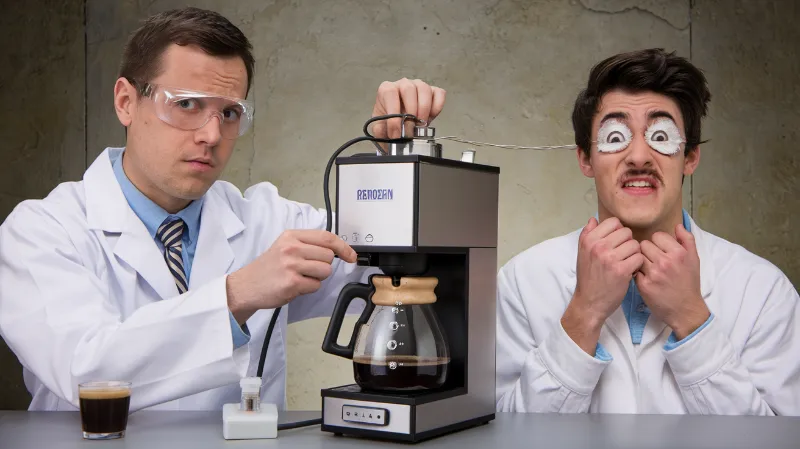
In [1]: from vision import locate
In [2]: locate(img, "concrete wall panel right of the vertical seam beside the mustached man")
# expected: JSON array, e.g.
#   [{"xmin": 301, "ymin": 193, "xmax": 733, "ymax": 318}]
[{"xmin": 692, "ymin": 0, "xmax": 800, "ymax": 287}]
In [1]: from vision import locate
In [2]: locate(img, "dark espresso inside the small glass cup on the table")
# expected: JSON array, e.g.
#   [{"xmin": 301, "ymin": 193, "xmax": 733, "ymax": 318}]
[{"xmin": 80, "ymin": 389, "xmax": 131, "ymax": 433}]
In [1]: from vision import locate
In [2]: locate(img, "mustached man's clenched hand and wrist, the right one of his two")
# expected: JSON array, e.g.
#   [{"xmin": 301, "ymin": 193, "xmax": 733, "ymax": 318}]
[{"xmin": 636, "ymin": 225, "xmax": 710, "ymax": 340}]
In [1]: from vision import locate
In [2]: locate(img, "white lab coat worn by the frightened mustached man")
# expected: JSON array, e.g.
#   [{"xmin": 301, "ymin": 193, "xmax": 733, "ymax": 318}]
[{"xmin": 497, "ymin": 217, "xmax": 800, "ymax": 415}]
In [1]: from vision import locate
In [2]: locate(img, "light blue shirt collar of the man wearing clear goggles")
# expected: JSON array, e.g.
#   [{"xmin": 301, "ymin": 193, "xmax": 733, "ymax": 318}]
[{"xmin": 111, "ymin": 151, "xmax": 203, "ymax": 242}]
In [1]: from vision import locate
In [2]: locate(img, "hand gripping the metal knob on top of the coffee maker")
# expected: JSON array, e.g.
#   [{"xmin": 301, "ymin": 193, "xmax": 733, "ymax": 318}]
[{"xmin": 372, "ymin": 78, "xmax": 447, "ymax": 139}]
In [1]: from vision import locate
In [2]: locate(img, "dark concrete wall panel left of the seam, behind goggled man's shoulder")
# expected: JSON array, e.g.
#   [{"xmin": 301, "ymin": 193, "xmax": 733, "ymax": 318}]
[{"xmin": 0, "ymin": 0, "xmax": 86, "ymax": 409}]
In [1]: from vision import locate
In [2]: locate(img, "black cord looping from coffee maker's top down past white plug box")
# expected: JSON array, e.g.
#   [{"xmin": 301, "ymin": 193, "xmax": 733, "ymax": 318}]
[{"xmin": 256, "ymin": 114, "xmax": 417, "ymax": 430}]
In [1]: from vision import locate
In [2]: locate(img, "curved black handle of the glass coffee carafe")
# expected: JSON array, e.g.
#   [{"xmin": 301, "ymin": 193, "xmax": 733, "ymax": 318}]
[{"xmin": 322, "ymin": 282, "xmax": 375, "ymax": 360}]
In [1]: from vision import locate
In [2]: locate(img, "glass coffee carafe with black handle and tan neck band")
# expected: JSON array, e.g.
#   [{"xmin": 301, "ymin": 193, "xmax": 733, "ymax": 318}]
[{"xmin": 322, "ymin": 275, "xmax": 450, "ymax": 391}]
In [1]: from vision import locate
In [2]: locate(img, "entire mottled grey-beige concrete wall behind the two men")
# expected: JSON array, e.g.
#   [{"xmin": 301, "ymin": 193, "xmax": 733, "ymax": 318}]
[{"xmin": 0, "ymin": 0, "xmax": 800, "ymax": 409}]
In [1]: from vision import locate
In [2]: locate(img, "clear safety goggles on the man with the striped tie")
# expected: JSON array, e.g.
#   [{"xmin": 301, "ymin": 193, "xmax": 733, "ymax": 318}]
[{"xmin": 134, "ymin": 83, "xmax": 253, "ymax": 139}]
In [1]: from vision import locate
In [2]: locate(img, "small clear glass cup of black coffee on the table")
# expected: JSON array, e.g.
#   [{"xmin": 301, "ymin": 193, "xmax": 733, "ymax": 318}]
[{"xmin": 78, "ymin": 381, "xmax": 131, "ymax": 440}]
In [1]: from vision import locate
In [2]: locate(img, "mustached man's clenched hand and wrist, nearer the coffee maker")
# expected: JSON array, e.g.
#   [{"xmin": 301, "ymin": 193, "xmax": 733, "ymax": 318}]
[{"xmin": 561, "ymin": 217, "xmax": 644, "ymax": 355}]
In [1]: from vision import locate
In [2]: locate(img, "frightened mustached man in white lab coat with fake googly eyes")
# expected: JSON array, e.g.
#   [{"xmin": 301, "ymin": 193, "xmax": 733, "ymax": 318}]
[{"xmin": 497, "ymin": 50, "xmax": 800, "ymax": 415}]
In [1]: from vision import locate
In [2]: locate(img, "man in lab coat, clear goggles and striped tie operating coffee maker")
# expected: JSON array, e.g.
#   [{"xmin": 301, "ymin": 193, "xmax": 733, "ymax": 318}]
[{"xmin": 0, "ymin": 8, "xmax": 444, "ymax": 410}]
